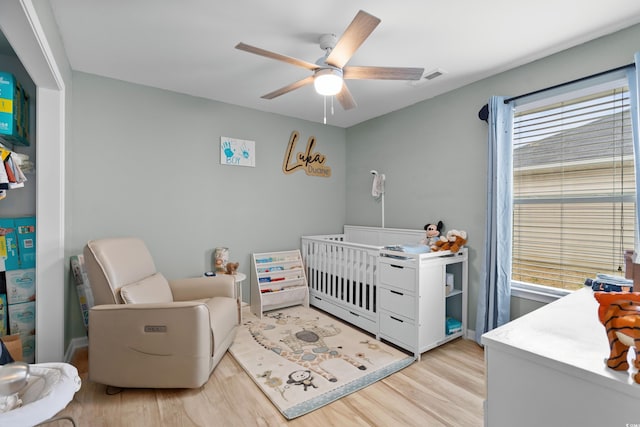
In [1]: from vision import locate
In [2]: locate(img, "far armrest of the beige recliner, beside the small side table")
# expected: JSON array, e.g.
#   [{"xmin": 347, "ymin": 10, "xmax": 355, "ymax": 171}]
[{"xmin": 169, "ymin": 274, "xmax": 237, "ymax": 301}]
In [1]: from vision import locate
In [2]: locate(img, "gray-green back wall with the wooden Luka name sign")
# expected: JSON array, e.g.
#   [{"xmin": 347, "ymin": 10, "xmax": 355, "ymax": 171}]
[{"xmin": 66, "ymin": 72, "xmax": 346, "ymax": 338}]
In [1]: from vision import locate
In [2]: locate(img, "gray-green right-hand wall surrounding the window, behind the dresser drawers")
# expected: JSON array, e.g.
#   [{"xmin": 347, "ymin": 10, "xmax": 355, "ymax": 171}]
[{"xmin": 346, "ymin": 25, "xmax": 640, "ymax": 329}]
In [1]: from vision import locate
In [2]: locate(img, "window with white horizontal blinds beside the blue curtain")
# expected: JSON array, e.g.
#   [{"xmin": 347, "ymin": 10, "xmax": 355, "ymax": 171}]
[{"xmin": 512, "ymin": 79, "xmax": 636, "ymax": 290}]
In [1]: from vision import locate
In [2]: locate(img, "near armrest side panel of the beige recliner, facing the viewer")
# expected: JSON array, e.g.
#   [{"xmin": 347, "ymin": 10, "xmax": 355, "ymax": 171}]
[{"xmin": 89, "ymin": 301, "xmax": 213, "ymax": 388}]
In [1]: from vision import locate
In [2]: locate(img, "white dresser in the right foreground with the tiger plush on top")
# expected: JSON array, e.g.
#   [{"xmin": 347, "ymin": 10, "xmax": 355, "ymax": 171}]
[{"xmin": 482, "ymin": 288, "xmax": 640, "ymax": 427}]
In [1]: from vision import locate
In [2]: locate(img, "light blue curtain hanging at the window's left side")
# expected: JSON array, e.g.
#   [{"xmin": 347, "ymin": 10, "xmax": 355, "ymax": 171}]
[{"xmin": 475, "ymin": 96, "xmax": 513, "ymax": 343}]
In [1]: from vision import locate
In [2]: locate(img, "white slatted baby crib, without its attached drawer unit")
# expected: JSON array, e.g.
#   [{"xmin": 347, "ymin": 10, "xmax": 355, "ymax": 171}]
[{"xmin": 301, "ymin": 225, "xmax": 425, "ymax": 334}]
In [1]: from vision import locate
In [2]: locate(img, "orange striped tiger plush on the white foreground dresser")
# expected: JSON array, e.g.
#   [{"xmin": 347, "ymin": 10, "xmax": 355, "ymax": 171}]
[{"xmin": 593, "ymin": 292, "xmax": 640, "ymax": 384}]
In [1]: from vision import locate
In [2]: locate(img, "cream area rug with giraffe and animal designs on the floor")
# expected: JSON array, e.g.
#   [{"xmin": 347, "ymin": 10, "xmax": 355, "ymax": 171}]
[{"xmin": 229, "ymin": 306, "xmax": 414, "ymax": 419}]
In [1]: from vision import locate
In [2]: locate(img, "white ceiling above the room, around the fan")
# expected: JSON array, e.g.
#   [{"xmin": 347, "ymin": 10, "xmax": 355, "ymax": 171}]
[{"xmin": 51, "ymin": 0, "xmax": 640, "ymax": 127}]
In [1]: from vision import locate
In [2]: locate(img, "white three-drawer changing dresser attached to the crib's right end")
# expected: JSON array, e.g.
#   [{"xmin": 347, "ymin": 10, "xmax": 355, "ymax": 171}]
[{"xmin": 377, "ymin": 248, "xmax": 468, "ymax": 359}]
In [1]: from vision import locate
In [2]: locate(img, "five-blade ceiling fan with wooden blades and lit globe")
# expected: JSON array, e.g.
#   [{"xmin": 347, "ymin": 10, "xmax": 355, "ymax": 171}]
[{"xmin": 236, "ymin": 10, "xmax": 424, "ymax": 110}]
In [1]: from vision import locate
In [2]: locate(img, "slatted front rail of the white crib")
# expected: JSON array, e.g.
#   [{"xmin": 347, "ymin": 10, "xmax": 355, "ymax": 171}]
[{"xmin": 301, "ymin": 234, "xmax": 381, "ymax": 318}]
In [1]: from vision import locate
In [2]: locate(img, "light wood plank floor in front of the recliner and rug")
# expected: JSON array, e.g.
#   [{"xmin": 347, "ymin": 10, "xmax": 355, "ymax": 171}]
[{"xmin": 49, "ymin": 338, "xmax": 485, "ymax": 427}]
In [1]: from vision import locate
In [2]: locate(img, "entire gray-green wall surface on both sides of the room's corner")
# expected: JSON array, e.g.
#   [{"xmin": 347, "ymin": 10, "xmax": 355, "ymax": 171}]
[{"xmin": 66, "ymin": 26, "xmax": 640, "ymax": 344}]
